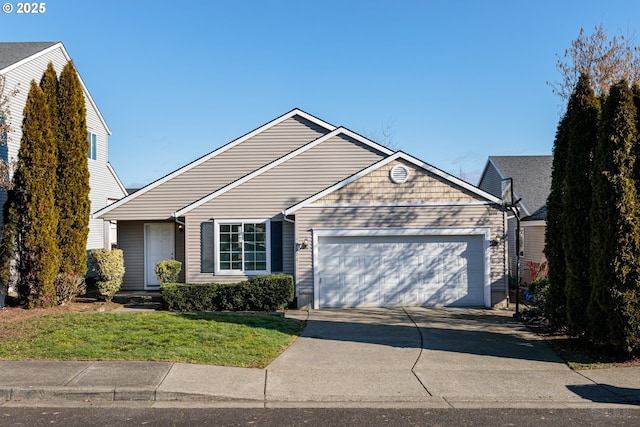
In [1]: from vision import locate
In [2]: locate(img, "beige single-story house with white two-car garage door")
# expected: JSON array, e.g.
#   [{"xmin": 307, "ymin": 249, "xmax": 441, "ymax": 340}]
[{"xmin": 94, "ymin": 109, "xmax": 507, "ymax": 308}]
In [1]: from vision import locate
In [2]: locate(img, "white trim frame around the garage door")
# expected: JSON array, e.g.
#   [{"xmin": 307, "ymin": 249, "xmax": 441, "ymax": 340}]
[{"xmin": 311, "ymin": 227, "xmax": 491, "ymax": 310}]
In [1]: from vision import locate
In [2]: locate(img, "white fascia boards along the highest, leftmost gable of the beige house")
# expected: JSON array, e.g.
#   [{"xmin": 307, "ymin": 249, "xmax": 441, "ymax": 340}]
[{"xmin": 96, "ymin": 108, "xmax": 336, "ymax": 219}]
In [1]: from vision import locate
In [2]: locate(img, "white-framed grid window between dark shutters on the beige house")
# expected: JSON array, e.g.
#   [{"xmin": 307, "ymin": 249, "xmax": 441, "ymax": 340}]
[{"xmin": 216, "ymin": 220, "xmax": 270, "ymax": 274}]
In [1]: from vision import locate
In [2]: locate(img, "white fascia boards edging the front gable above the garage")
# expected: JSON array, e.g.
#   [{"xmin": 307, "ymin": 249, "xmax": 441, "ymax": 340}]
[{"xmin": 283, "ymin": 151, "xmax": 501, "ymax": 215}]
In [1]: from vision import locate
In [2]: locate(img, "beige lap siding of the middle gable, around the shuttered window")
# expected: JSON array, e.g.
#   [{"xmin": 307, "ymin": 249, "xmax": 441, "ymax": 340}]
[{"xmin": 182, "ymin": 136, "xmax": 382, "ymax": 282}]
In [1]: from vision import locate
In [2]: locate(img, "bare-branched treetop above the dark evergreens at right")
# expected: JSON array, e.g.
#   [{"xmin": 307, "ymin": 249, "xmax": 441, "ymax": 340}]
[{"xmin": 547, "ymin": 24, "xmax": 640, "ymax": 103}]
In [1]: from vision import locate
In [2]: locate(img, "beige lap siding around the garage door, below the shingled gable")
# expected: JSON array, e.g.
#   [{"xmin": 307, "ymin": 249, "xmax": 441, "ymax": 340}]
[{"xmin": 296, "ymin": 206, "xmax": 505, "ymax": 304}]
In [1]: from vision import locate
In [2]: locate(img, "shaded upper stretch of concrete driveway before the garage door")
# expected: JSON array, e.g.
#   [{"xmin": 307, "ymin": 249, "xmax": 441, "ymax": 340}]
[{"xmin": 302, "ymin": 307, "xmax": 564, "ymax": 364}]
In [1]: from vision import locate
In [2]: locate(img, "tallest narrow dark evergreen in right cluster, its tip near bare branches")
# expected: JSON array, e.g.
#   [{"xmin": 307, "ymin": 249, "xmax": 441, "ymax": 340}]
[{"xmin": 564, "ymin": 74, "xmax": 600, "ymax": 335}]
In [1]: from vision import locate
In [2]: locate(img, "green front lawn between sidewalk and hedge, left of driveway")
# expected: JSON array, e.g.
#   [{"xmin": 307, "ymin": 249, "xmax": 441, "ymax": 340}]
[{"xmin": 0, "ymin": 312, "xmax": 304, "ymax": 367}]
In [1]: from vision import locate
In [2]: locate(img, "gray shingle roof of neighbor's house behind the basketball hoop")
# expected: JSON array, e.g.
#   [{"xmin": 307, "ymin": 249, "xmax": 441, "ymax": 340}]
[{"xmin": 489, "ymin": 156, "xmax": 553, "ymax": 215}]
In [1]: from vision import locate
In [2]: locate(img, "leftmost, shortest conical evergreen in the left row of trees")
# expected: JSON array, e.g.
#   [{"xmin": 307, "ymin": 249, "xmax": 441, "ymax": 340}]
[{"xmin": 15, "ymin": 81, "xmax": 59, "ymax": 307}]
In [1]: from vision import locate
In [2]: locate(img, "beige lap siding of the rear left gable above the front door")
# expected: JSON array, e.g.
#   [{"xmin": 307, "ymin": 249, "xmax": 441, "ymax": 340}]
[{"xmin": 105, "ymin": 116, "xmax": 327, "ymax": 220}]
